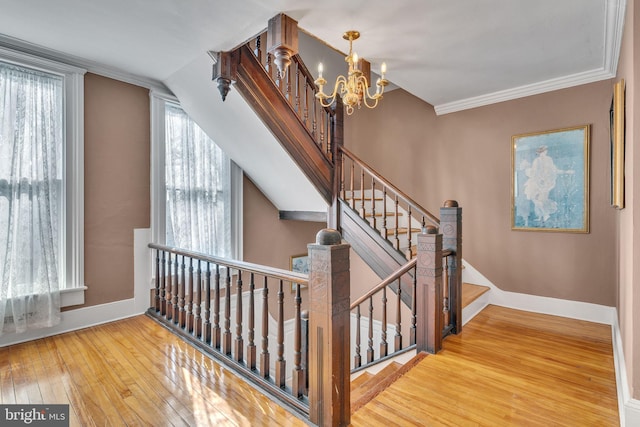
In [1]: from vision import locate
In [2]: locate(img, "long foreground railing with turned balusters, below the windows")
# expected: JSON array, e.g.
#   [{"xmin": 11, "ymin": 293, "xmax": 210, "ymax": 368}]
[{"xmin": 148, "ymin": 244, "xmax": 309, "ymax": 414}]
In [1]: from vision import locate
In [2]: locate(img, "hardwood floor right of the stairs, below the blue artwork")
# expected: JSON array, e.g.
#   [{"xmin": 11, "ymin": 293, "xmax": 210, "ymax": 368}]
[{"xmin": 351, "ymin": 306, "xmax": 619, "ymax": 427}]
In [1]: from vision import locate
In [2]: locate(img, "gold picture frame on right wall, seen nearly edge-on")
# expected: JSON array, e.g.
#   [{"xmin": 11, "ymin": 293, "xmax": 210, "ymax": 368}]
[{"xmin": 609, "ymin": 79, "xmax": 625, "ymax": 209}]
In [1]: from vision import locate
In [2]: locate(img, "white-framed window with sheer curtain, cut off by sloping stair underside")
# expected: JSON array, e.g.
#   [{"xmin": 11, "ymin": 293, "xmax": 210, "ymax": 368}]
[{"xmin": 152, "ymin": 96, "xmax": 242, "ymax": 258}]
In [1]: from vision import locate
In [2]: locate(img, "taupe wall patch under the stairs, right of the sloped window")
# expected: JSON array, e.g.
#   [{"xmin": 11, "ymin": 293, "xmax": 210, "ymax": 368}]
[{"xmin": 242, "ymin": 176, "xmax": 326, "ymax": 269}]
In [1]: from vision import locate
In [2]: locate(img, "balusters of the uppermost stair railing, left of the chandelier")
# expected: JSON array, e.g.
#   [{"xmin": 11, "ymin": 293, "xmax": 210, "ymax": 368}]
[{"xmin": 247, "ymin": 32, "xmax": 335, "ymax": 160}]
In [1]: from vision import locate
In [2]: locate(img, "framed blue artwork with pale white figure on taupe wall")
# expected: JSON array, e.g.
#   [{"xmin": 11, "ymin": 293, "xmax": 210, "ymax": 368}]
[{"xmin": 511, "ymin": 125, "xmax": 590, "ymax": 233}]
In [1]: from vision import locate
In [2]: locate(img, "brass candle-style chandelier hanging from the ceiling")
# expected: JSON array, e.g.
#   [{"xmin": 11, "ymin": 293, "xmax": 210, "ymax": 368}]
[{"xmin": 314, "ymin": 30, "xmax": 389, "ymax": 115}]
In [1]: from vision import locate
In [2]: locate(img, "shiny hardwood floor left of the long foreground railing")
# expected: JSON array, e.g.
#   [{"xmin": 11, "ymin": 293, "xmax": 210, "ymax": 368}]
[{"xmin": 0, "ymin": 316, "xmax": 305, "ymax": 426}]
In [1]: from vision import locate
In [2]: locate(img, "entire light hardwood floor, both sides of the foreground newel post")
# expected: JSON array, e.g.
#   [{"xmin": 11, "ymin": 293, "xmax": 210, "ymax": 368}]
[{"xmin": 0, "ymin": 306, "xmax": 618, "ymax": 427}]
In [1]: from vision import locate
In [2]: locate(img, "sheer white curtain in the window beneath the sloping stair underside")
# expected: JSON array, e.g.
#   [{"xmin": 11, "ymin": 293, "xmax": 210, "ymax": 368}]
[{"xmin": 165, "ymin": 103, "xmax": 232, "ymax": 258}]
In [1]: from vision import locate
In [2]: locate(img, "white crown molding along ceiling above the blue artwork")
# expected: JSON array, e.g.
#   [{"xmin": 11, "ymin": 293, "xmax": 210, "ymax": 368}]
[{"xmin": 434, "ymin": 0, "xmax": 627, "ymax": 115}]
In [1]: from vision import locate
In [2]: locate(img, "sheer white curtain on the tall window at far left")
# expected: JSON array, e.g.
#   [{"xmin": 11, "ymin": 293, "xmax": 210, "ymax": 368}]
[{"xmin": 0, "ymin": 62, "xmax": 64, "ymax": 334}]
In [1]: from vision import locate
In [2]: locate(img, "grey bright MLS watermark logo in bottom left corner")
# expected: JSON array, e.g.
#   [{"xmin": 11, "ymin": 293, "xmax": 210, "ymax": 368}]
[{"xmin": 0, "ymin": 405, "xmax": 69, "ymax": 427}]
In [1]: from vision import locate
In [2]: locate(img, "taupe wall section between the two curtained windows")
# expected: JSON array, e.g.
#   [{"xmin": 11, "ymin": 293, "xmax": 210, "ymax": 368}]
[{"xmin": 84, "ymin": 74, "xmax": 150, "ymax": 306}]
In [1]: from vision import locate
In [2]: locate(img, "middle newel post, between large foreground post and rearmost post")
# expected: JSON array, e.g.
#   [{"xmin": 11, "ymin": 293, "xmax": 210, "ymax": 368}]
[{"xmin": 415, "ymin": 225, "xmax": 443, "ymax": 353}]
